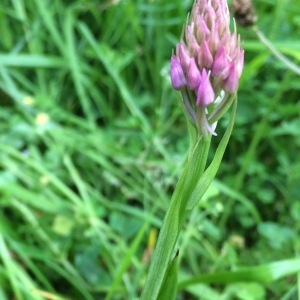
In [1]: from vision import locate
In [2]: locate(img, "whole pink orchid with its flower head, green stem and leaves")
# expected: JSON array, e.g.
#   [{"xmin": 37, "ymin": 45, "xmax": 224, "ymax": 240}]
[{"xmin": 141, "ymin": 0, "xmax": 244, "ymax": 300}]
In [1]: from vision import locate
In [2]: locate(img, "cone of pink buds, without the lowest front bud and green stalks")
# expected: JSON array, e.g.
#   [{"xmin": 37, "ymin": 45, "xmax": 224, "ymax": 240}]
[{"xmin": 171, "ymin": 0, "xmax": 244, "ymax": 96}]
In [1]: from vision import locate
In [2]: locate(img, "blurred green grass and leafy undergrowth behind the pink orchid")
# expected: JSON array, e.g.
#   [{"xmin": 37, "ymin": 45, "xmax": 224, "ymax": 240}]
[{"xmin": 0, "ymin": 0, "xmax": 300, "ymax": 300}]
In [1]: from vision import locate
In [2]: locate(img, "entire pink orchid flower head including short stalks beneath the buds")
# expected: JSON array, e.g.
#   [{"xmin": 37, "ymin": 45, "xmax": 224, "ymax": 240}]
[{"xmin": 170, "ymin": 0, "xmax": 244, "ymax": 136}]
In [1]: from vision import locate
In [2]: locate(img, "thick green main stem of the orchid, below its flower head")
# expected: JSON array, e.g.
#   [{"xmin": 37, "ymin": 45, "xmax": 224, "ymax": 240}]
[{"xmin": 141, "ymin": 138, "xmax": 210, "ymax": 300}]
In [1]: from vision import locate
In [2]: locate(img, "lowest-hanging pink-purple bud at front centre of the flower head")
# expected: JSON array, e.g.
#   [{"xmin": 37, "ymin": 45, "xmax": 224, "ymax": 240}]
[{"xmin": 196, "ymin": 69, "xmax": 215, "ymax": 106}]
